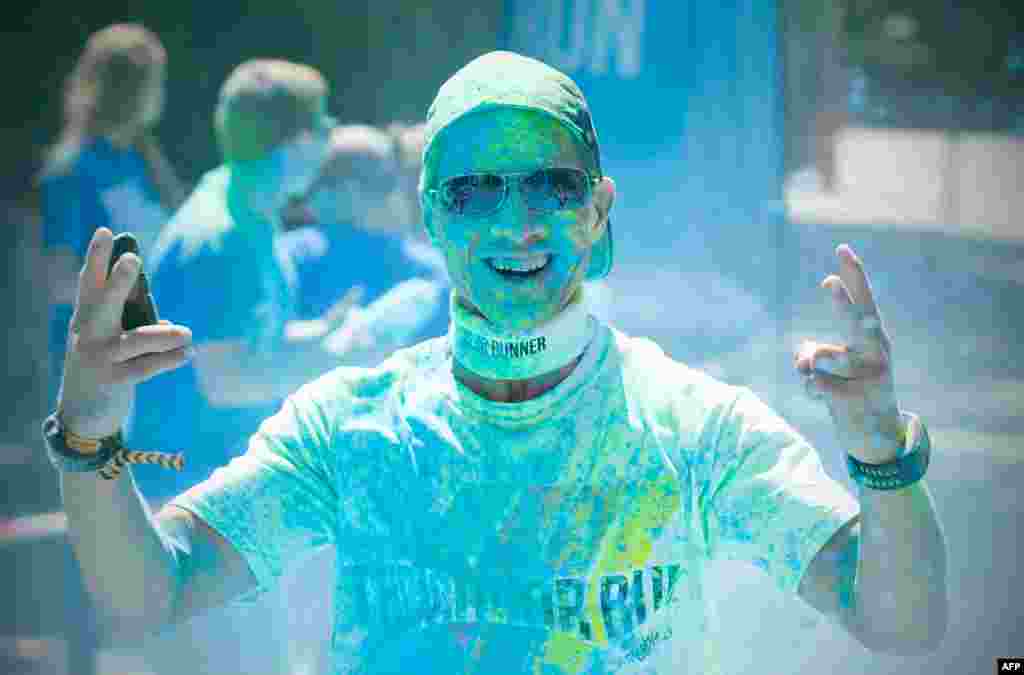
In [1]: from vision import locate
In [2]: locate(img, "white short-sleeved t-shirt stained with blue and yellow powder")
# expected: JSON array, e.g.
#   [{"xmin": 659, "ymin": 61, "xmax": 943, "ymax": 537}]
[{"xmin": 175, "ymin": 325, "xmax": 857, "ymax": 675}]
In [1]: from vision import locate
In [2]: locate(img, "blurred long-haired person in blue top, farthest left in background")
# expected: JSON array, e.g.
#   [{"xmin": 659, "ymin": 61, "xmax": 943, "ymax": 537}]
[{"xmin": 38, "ymin": 24, "xmax": 185, "ymax": 407}]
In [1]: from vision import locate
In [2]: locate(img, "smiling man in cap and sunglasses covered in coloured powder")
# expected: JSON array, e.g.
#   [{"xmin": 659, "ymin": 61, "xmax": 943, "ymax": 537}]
[{"xmin": 46, "ymin": 52, "xmax": 946, "ymax": 675}]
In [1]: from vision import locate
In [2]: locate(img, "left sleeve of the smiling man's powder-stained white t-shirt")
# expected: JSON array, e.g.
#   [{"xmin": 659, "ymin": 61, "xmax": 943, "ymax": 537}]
[{"xmin": 172, "ymin": 385, "xmax": 338, "ymax": 592}]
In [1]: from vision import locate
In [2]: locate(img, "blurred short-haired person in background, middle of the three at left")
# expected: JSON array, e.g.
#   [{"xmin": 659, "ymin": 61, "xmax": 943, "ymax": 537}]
[{"xmin": 126, "ymin": 59, "xmax": 355, "ymax": 674}]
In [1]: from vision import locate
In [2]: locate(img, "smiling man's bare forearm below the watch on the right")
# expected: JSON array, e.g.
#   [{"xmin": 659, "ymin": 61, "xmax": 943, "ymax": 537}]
[{"xmin": 855, "ymin": 481, "xmax": 948, "ymax": 651}]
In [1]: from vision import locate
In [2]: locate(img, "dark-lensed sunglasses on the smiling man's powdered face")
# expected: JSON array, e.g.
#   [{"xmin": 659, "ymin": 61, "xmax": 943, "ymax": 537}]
[{"xmin": 427, "ymin": 168, "xmax": 601, "ymax": 217}]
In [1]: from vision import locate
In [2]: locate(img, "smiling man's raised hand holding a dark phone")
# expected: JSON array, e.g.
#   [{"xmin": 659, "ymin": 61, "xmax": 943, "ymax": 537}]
[{"xmin": 58, "ymin": 227, "xmax": 191, "ymax": 438}]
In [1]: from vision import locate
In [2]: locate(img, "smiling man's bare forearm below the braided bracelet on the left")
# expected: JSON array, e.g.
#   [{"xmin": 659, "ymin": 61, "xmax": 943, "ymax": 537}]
[{"xmin": 60, "ymin": 467, "xmax": 179, "ymax": 634}]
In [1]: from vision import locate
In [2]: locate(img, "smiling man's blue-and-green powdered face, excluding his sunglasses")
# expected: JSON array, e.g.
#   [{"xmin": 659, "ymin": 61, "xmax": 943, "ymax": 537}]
[{"xmin": 424, "ymin": 109, "xmax": 612, "ymax": 331}]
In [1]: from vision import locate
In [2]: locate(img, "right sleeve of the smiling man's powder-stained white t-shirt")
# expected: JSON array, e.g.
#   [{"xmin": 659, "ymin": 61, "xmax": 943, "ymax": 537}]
[{"xmin": 707, "ymin": 388, "xmax": 859, "ymax": 591}]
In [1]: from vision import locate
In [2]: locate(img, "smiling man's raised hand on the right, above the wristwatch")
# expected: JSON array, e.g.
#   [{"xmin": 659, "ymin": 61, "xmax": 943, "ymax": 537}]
[{"xmin": 796, "ymin": 244, "xmax": 902, "ymax": 464}]
